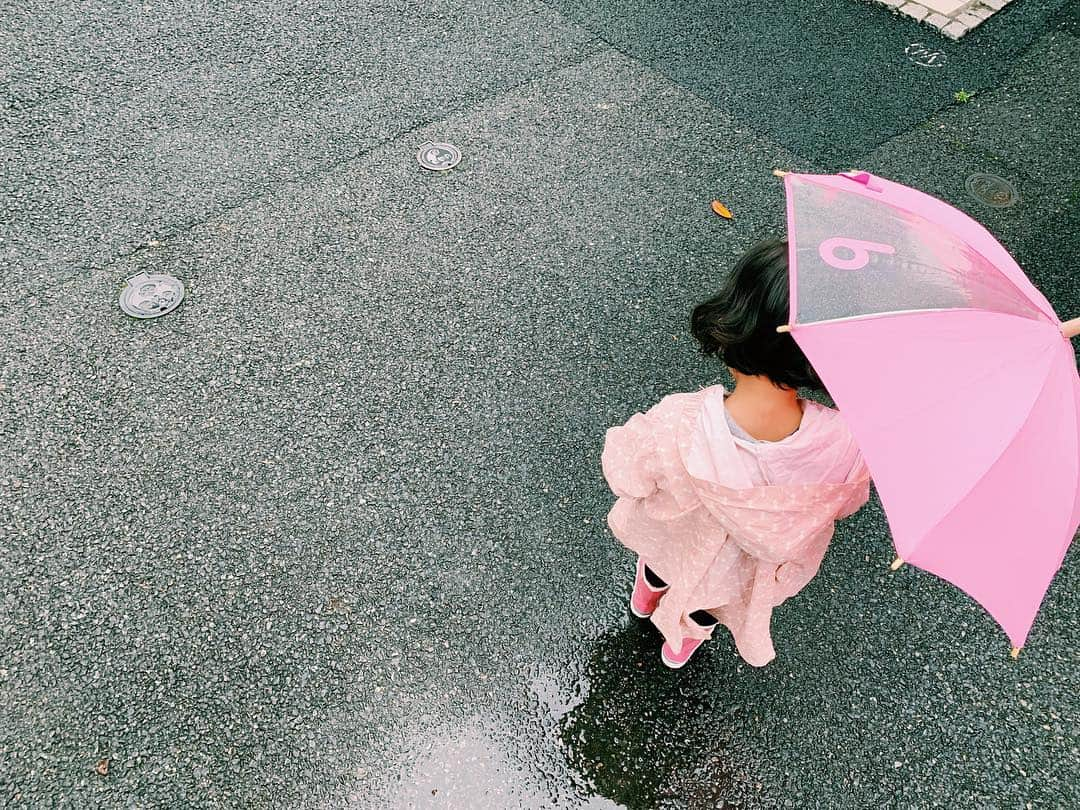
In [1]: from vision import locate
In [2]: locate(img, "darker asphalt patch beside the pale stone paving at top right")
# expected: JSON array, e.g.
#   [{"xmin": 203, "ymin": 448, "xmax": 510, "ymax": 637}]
[{"xmin": 550, "ymin": 0, "xmax": 1071, "ymax": 165}]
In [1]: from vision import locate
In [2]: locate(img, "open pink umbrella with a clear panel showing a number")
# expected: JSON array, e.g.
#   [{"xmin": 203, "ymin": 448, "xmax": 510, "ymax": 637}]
[{"xmin": 778, "ymin": 172, "xmax": 1080, "ymax": 654}]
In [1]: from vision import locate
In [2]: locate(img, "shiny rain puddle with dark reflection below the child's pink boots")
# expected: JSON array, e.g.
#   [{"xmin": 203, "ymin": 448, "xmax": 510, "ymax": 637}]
[{"xmin": 369, "ymin": 622, "xmax": 751, "ymax": 810}]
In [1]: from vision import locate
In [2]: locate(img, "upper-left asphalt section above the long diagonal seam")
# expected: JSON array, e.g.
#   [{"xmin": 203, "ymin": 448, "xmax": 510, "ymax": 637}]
[{"xmin": 0, "ymin": 0, "xmax": 597, "ymax": 274}]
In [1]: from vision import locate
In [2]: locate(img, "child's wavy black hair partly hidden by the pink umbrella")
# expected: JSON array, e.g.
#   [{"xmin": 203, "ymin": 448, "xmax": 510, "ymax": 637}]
[{"xmin": 690, "ymin": 240, "xmax": 822, "ymax": 389}]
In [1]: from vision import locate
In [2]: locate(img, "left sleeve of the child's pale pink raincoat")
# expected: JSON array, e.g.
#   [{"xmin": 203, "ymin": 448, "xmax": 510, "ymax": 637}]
[{"xmin": 600, "ymin": 395, "xmax": 675, "ymax": 498}]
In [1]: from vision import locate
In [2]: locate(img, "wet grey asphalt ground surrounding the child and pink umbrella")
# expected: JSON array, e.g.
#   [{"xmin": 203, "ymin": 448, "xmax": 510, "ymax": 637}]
[{"xmin": 0, "ymin": 0, "xmax": 1080, "ymax": 810}]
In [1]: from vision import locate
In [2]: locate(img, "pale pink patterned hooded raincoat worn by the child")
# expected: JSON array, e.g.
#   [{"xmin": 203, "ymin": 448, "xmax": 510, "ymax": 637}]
[{"xmin": 603, "ymin": 386, "xmax": 869, "ymax": 666}]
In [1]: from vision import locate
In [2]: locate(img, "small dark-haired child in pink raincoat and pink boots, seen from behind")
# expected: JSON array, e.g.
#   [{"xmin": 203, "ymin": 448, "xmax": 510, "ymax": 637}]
[{"xmin": 603, "ymin": 241, "xmax": 869, "ymax": 669}]
